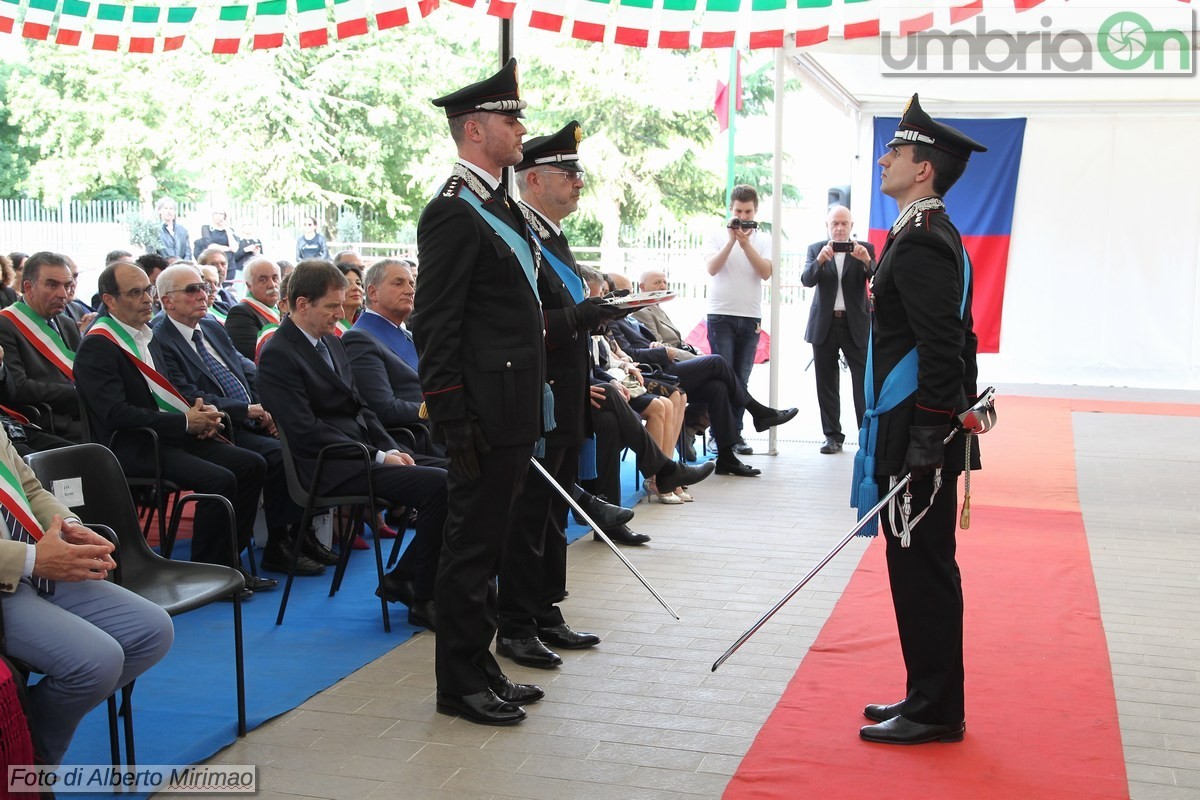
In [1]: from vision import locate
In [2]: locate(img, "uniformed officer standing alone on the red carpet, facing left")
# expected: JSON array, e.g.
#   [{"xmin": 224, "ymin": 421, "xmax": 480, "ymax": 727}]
[{"xmin": 852, "ymin": 95, "xmax": 986, "ymax": 745}]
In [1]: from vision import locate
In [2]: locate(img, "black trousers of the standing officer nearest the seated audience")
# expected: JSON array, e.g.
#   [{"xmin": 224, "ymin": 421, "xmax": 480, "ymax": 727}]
[{"xmin": 434, "ymin": 443, "xmax": 533, "ymax": 694}]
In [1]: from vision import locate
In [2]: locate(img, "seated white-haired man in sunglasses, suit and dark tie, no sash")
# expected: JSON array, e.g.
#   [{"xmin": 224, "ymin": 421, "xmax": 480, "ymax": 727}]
[{"xmin": 150, "ymin": 263, "xmax": 337, "ymax": 576}]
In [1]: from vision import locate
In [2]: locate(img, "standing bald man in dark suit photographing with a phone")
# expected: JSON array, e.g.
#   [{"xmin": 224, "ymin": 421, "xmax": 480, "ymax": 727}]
[{"xmin": 800, "ymin": 205, "xmax": 875, "ymax": 456}]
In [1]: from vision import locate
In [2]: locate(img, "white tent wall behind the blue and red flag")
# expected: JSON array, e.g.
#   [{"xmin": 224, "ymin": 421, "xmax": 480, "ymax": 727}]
[{"xmin": 844, "ymin": 102, "xmax": 1200, "ymax": 390}]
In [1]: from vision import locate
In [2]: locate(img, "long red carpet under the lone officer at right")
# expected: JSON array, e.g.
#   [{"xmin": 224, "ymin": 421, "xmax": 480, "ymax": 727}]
[{"xmin": 725, "ymin": 397, "xmax": 1200, "ymax": 800}]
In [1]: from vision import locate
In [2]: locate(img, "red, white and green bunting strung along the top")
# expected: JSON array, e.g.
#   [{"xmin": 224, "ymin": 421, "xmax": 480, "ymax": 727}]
[{"xmin": 0, "ymin": 0, "xmax": 1161, "ymax": 54}]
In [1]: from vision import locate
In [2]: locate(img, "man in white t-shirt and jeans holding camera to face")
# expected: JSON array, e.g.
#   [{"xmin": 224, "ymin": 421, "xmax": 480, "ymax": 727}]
[{"xmin": 706, "ymin": 184, "xmax": 770, "ymax": 456}]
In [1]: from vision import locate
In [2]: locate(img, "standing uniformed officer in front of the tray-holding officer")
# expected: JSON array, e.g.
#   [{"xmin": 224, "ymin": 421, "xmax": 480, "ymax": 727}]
[{"xmin": 412, "ymin": 59, "xmax": 546, "ymax": 724}]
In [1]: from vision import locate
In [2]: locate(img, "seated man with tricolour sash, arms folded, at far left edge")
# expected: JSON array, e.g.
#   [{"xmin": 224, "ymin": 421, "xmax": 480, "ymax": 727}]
[{"xmin": 0, "ymin": 252, "xmax": 83, "ymax": 441}]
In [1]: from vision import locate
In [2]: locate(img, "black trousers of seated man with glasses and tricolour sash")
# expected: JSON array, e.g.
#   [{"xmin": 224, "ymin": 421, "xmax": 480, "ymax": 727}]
[{"xmin": 116, "ymin": 441, "xmax": 266, "ymax": 566}]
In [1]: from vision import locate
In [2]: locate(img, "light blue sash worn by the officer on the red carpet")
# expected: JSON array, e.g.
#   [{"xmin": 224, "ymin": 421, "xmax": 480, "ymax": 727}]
[{"xmin": 850, "ymin": 247, "xmax": 971, "ymax": 536}]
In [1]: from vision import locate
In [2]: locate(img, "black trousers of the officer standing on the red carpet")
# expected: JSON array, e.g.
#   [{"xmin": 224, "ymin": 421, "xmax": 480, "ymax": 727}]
[{"xmin": 875, "ymin": 474, "xmax": 965, "ymax": 724}]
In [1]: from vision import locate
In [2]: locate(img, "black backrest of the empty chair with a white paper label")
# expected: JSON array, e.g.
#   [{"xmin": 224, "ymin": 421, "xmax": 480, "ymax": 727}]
[{"xmin": 25, "ymin": 444, "xmax": 162, "ymax": 583}]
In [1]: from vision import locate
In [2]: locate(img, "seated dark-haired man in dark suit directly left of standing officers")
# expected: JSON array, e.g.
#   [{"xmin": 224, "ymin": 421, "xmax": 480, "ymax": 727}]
[{"xmin": 258, "ymin": 259, "xmax": 446, "ymax": 630}]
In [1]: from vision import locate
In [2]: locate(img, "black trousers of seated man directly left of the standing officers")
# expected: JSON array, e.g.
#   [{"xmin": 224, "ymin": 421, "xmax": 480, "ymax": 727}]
[{"xmin": 330, "ymin": 464, "xmax": 446, "ymax": 601}]
